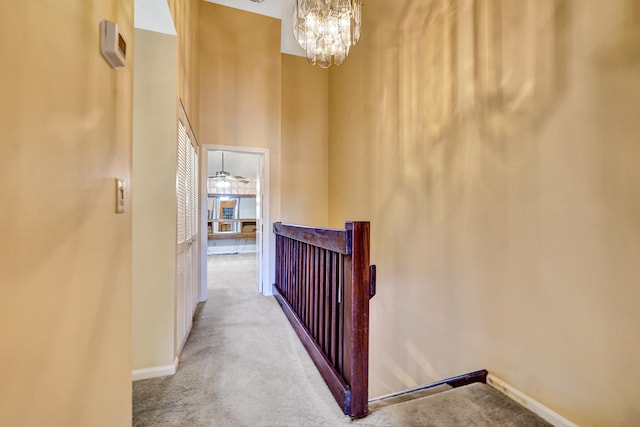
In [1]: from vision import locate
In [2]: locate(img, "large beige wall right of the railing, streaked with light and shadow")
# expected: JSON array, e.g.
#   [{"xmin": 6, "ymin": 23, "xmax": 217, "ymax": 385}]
[{"xmin": 330, "ymin": 0, "xmax": 640, "ymax": 426}]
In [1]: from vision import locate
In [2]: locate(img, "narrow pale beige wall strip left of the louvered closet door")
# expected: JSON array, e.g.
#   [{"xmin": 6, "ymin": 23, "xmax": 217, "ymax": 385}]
[{"xmin": 132, "ymin": 29, "xmax": 178, "ymax": 370}]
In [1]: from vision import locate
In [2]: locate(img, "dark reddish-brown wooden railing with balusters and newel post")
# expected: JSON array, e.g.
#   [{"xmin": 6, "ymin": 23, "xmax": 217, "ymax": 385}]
[{"xmin": 273, "ymin": 222, "xmax": 375, "ymax": 418}]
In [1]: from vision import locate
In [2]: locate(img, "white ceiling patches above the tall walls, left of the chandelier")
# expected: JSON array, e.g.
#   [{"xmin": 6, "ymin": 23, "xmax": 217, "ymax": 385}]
[{"xmin": 134, "ymin": 0, "xmax": 304, "ymax": 56}]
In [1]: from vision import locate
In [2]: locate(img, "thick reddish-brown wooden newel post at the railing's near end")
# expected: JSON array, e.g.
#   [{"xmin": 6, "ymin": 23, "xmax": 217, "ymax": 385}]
[{"xmin": 344, "ymin": 222, "xmax": 370, "ymax": 418}]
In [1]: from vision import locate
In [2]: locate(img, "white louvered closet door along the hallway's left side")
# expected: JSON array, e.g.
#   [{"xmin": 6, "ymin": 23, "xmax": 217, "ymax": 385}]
[{"xmin": 176, "ymin": 110, "xmax": 199, "ymax": 355}]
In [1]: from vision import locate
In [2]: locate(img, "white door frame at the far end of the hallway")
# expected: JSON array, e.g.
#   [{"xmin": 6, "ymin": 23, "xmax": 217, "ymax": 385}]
[{"xmin": 200, "ymin": 144, "xmax": 273, "ymax": 302}]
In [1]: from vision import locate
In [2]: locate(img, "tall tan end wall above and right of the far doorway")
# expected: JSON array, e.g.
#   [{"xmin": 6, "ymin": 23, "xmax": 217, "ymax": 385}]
[{"xmin": 199, "ymin": 2, "xmax": 336, "ymax": 288}]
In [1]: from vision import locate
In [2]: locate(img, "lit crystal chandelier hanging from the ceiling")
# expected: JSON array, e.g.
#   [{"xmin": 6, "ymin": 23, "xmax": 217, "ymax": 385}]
[{"xmin": 293, "ymin": 0, "xmax": 362, "ymax": 68}]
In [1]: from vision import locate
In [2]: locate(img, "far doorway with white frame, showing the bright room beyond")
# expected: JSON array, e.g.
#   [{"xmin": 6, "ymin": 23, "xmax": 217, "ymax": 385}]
[{"xmin": 200, "ymin": 144, "xmax": 271, "ymax": 301}]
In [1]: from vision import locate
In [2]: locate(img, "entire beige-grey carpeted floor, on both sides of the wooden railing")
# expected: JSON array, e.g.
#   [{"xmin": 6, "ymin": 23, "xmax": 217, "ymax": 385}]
[{"xmin": 133, "ymin": 254, "xmax": 548, "ymax": 427}]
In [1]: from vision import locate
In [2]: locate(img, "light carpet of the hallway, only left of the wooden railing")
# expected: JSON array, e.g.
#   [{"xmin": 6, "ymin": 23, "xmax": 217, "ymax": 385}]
[{"xmin": 133, "ymin": 254, "xmax": 348, "ymax": 427}]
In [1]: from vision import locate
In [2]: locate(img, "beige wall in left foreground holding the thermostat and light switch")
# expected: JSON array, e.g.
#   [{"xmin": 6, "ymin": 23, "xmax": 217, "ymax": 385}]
[{"xmin": 0, "ymin": 0, "xmax": 134, "ymax": 427}]
